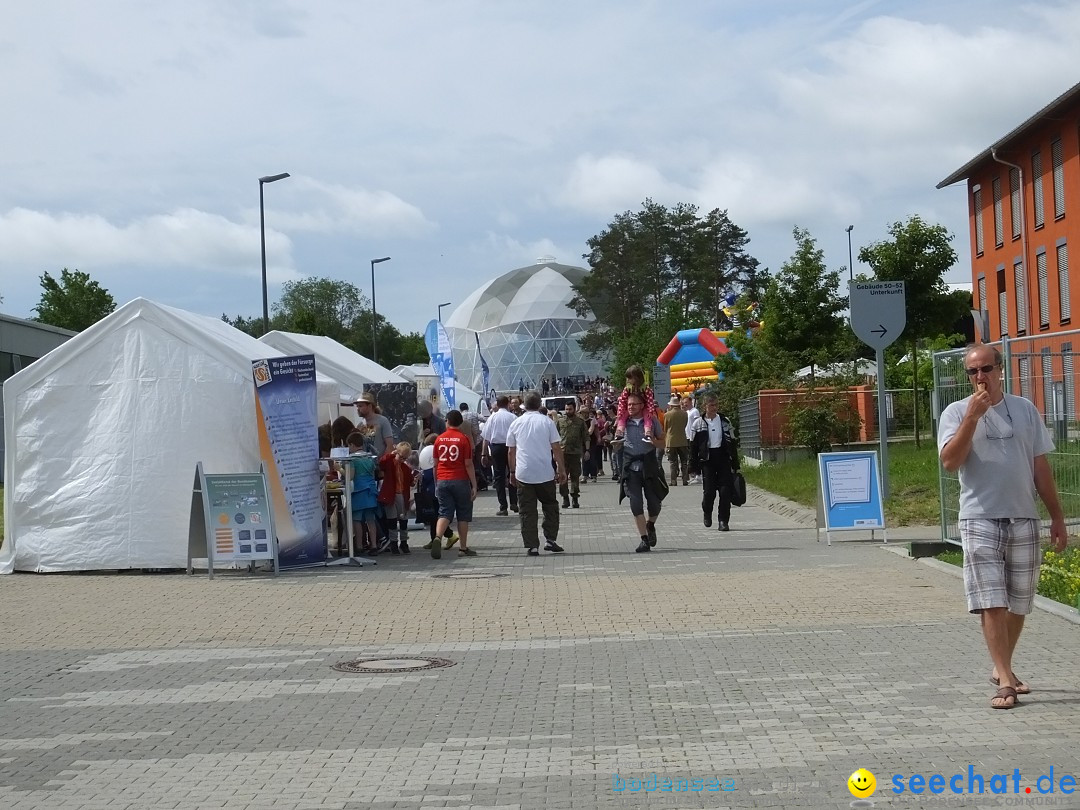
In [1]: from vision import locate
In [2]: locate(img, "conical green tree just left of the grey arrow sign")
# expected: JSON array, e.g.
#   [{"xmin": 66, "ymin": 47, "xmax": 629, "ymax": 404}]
[{"xmin": 758, "ymin": 228, "xmax": 853, "ymax": 384}]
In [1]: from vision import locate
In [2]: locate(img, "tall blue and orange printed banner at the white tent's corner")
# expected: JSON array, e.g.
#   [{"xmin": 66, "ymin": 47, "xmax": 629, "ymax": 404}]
[{"xmin": 252, "ymin": 354, "xmax": 326, "ymax": 568}]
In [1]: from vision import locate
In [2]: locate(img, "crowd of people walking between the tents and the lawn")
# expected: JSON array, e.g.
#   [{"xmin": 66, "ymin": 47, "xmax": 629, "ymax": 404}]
[{"xmin": 321, "ymin": 366, "xmax": 739, "ymax": 558}]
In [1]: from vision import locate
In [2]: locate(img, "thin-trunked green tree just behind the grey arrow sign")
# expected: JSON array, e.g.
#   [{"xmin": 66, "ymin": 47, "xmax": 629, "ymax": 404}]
[{"xmin": 859, "ymin": 215, "xmax": 970, "ymax": 447}]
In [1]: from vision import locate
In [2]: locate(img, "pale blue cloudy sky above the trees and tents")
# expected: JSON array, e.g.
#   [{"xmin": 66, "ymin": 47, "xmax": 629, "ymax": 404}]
[{"xmin": 0, "ymin": 0, "xmax": 1080, "ymax": 332}]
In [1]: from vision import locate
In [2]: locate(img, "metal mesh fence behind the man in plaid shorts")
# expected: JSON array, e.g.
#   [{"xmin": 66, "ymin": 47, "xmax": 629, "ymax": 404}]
[{"xmin": 933, "ymin": 329, "xmax": 1080, "ymax": 542}]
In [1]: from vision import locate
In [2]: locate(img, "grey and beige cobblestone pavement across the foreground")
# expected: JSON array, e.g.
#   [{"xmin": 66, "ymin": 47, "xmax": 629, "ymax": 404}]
[{"xmin": 0, "ymin": 482, "xmax": 1080, "ymax": 810}]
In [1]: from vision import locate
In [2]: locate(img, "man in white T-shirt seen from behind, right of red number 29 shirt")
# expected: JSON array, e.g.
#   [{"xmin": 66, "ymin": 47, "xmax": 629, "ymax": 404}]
[{"xmin": 507, "ymin": 391, "xmax": 566, "ymax": 557}]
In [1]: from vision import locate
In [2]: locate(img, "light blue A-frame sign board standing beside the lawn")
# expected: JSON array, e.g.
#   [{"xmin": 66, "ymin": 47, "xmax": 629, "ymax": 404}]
[{"xmin": 818, "ymin": 450, "xmax": 885, "ymax": 531}]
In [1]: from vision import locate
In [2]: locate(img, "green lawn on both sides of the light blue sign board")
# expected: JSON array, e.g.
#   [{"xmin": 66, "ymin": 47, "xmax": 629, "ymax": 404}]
[{"xmin": 743, "ymin": 441, "xmax": 941, "ymax": 526}]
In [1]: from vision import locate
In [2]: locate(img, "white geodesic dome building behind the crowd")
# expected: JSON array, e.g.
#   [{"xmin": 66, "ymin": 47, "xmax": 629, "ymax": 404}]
[{"xmin": 443, "ymin": 257, "xmax": 604, "ymax": 391}]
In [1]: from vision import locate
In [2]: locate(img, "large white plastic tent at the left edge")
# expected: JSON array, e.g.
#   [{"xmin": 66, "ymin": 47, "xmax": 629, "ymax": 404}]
[{"xmin": 0, "ymin": 298, "xmax": 340, "ymax": 573}]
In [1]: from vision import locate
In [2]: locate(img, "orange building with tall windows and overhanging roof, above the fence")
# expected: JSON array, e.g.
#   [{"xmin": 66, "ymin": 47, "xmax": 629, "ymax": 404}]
[{"xmin": 937, "ymin": 84, "xmax": 1080, "ymax": 340}]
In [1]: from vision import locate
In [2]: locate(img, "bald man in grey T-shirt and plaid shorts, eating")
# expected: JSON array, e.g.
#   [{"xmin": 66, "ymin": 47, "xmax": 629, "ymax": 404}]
[{"xmin": 937, "ymin": 345, "xmax": 1066, "ymax": 708}]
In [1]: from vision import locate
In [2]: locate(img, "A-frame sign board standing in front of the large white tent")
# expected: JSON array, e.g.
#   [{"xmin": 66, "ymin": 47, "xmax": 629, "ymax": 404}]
[{"xmin": 188, "ymin": 461, "xmax": 280, "ymax": 579}]
